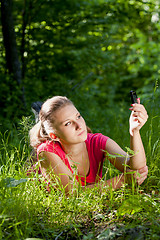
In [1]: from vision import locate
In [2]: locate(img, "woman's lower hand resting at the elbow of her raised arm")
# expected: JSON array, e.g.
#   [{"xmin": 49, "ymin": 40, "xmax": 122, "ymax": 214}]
[{"xmin": 125, "ymin": 166, "xmax": 148, "ymax": 185}]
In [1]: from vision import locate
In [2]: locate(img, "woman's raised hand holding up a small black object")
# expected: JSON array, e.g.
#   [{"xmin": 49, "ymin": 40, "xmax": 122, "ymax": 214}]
[{"xmin": 130, "ymin": 98, "xmax": 148, "ymax": 135}]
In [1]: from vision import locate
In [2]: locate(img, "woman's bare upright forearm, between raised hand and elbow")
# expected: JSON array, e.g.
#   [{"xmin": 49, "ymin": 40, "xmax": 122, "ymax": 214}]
[{"xmin": 129, "ymin": 131, "xmax": 146, "ymax": 170}]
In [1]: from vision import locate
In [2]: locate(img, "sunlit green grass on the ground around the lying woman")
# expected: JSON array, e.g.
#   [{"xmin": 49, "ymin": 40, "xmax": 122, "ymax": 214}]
[{"xmin": 0, "ymin": 94, "xmax": 160, "ymax": 240}]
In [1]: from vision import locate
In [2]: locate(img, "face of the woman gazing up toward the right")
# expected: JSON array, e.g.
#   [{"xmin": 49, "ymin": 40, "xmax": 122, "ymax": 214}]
[{"xmin": 54, "ymin": 104, "xmax": 87, "ymax": 144}]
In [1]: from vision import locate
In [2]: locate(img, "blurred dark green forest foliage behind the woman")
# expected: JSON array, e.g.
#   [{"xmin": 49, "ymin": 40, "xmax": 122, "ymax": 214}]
[{"xmin": 0, "ymin": 0, "xmax": 160, "ymax": 130}]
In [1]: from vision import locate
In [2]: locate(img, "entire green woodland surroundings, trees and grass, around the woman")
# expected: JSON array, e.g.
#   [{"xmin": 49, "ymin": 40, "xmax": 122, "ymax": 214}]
[{"xmin": 0, "ymin": 0, "xmax": 160, "ymax": 240}]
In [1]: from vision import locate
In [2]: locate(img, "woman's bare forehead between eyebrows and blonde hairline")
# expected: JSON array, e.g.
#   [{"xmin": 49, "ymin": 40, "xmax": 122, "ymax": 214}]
[{"xmin": 55, "ymin": 104, "xmax": 78, "ymax": 124}]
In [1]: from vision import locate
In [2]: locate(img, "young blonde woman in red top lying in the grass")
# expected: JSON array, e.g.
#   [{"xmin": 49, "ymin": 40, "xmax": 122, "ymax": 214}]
[{"xmin": 30, "ymin": 96, "xmax": 148, "ymax": 193}]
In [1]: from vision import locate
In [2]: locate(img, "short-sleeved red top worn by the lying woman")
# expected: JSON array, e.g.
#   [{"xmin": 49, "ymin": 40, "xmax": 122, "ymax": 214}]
[{"xmin": 37, "ymin": 133, "xmax": 109, "ymax": 186}]
